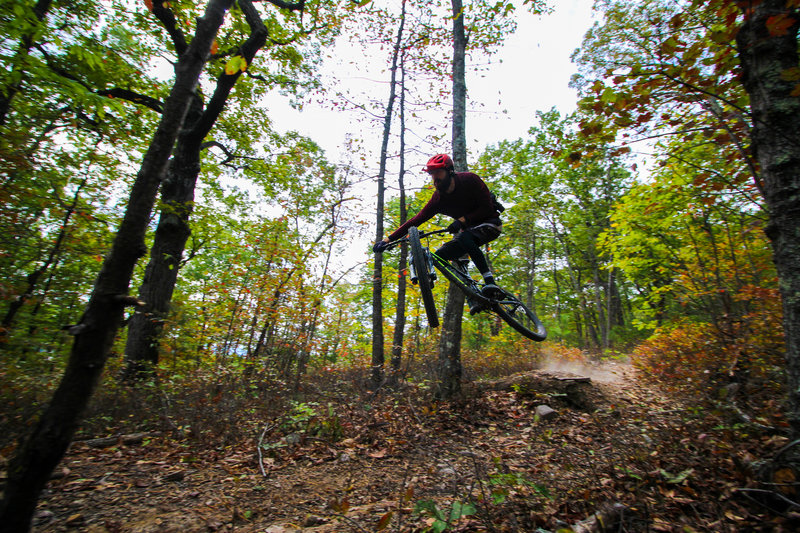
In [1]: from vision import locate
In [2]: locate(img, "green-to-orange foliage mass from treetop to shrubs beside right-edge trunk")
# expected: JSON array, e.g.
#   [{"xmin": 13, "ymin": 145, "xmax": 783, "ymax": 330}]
[{"xmin": 573, "ymin": 0, "xmax": 783, "ymax": 406}]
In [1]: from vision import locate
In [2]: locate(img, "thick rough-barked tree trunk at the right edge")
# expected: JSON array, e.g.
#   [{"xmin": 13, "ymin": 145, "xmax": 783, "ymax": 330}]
[{"xmin": 736, "ymin": 0, "xmax": 800, "ymax": 438}]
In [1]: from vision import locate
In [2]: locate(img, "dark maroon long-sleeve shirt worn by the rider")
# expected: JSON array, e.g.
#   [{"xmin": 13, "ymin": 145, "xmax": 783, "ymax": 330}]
[{"xmin": 389, "ymin": 172, "xmax": 500, "ymax": 241}]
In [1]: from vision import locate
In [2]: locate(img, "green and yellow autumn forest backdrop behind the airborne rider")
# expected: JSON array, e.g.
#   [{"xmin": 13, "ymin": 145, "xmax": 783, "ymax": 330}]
[{"xmin": 0, "ymin": 0, "xmax": 800, "ymax": 528}]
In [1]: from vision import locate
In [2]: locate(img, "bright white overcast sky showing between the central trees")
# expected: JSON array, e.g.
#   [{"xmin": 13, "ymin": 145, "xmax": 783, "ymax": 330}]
[{"xmin": 255, "ymin": 0, "xmax": 593, "ymax": 267}]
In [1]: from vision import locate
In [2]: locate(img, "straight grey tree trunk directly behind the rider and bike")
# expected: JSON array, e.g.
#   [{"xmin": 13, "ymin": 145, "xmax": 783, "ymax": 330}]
[{"xmin": 439, "ymin": 0, "xmax": 467, "ymax": 398}]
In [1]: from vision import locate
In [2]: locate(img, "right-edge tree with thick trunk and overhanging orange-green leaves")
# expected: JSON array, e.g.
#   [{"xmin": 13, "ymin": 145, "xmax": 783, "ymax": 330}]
[{"xmin": 568, "ymin": 0, "xmax": 800, "ymax": 434}]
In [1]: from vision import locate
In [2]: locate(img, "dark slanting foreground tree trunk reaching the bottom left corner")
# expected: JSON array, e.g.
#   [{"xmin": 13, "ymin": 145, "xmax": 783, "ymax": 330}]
[{"xmin": 0, "ymin": 0, "xmax": 231, "ymax": 533}]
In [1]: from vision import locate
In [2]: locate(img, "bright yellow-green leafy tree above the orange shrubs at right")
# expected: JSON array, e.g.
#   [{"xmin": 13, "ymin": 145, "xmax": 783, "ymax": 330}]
[{"xmin": 600, "ymin": 137, "xmax": 777, "ymax": 335}]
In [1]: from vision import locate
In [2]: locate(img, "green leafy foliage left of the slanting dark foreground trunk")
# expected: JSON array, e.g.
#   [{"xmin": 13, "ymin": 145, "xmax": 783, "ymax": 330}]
[{"xmin": 0, "ymin": 1, "xmax": 166, "ymax": 353}]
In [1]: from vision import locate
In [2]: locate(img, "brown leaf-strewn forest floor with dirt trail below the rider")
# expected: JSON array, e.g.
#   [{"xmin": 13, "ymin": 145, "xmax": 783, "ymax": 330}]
[{"xmin": 18, "ymin": 365, "xmax": 800, "ymax": 533}]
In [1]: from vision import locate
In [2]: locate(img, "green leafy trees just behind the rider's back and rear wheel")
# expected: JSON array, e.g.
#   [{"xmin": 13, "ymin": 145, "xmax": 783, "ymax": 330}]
[{"xmin": 476, "ymin": 111, "xmax": 630, "ymax": 349}]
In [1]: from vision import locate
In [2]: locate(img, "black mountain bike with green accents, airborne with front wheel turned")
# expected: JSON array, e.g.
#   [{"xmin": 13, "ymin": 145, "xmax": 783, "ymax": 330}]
[{"xmin": 386, "ymin": 226, "xmax": 547, "ymax": 341}]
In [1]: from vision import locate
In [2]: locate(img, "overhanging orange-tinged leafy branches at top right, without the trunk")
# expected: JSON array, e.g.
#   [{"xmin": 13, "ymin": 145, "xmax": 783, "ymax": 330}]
[{"xmin": 573, "ymin": 0, "xmax": 754, "ymax": 187}]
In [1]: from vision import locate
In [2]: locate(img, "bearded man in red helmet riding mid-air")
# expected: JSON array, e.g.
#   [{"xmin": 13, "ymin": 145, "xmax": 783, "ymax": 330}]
[{"xmin": 372, "ymin": 154, "xmax": 503, "ymax": 314}]
